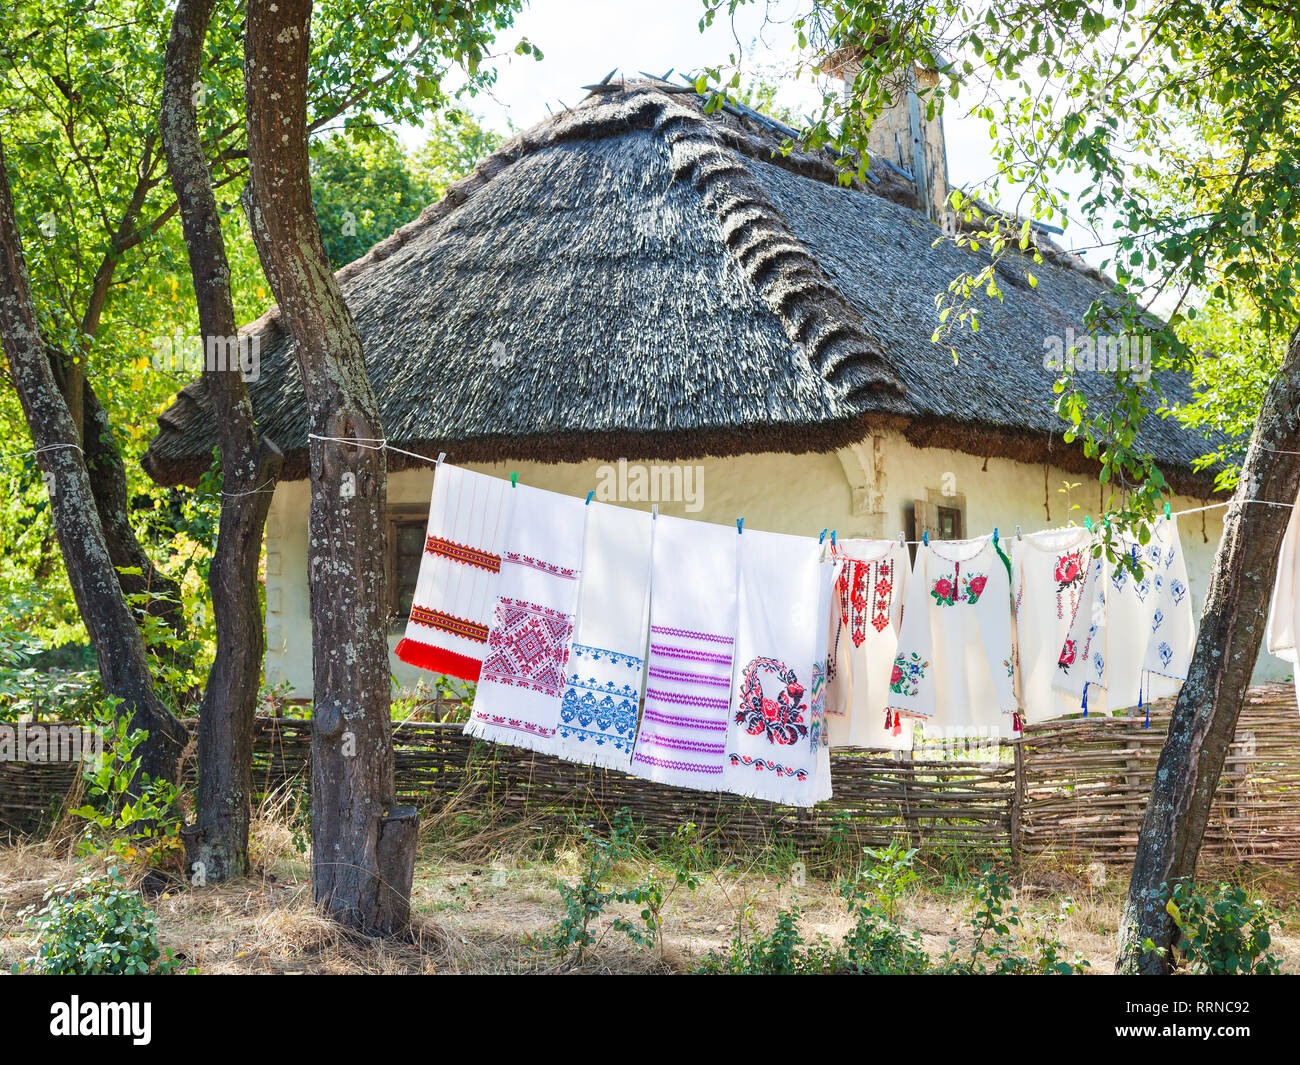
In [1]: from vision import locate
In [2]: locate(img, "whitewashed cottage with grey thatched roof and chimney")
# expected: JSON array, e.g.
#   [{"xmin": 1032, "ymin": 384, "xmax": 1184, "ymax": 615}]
[{"xmin": 146, "ymin": 81, "xmax": 1281, "ymax": 696}]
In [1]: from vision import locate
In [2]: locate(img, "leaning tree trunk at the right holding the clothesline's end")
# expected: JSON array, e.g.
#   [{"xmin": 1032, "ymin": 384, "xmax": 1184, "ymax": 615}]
[{"xmin": 1117, "ymin": 329, "xmax": 1300, "ymax": 974}]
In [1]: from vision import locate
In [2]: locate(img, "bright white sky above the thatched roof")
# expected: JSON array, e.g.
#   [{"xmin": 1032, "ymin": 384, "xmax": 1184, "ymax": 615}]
[{"xmin": 444, "ymin": 0, "xmax": 1093, "ymax": 257}]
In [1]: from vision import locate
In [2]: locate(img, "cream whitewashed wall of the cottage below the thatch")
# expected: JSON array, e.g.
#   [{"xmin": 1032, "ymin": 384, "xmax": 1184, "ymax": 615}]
[{"xmin": 258, "ymin": 436, "xmax": 1291, "ymax": 698}]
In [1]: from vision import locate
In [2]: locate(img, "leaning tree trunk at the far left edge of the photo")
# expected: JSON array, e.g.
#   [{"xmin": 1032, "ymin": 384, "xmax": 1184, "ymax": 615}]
[{"xmin": 0, "ymin": 135, "xmax": 186, "ymax": 782}]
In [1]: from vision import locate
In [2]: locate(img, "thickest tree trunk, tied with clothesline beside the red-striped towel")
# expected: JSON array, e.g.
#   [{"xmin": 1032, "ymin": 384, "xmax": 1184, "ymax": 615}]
[{"xmin": 244, "ymin": 0, "xmax": 415, "ymax": 932}]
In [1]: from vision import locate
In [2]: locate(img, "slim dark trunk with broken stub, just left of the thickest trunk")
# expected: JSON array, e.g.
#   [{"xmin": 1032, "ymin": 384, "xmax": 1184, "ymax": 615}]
[{"xmin": 160, "ymin": 0, "xmax": 283, "ymax": 882}]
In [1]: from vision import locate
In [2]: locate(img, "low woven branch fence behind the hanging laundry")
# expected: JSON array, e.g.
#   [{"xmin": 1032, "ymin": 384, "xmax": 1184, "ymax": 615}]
[{"xmin": 0, "ymin": 684, "xmax": 1300, "ymax": 862}]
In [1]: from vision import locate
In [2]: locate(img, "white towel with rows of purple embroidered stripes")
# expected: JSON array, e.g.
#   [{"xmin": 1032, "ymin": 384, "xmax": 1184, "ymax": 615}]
[{"xmin": 632, "ymin": 515, "xmax": 741, "ymax": 791}]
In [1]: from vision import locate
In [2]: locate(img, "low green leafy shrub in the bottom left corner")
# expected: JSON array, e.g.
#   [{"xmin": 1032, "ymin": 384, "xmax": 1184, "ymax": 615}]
[{"xmin": 14, "ymin": 870, "xmax": 183, "ymax": 977}]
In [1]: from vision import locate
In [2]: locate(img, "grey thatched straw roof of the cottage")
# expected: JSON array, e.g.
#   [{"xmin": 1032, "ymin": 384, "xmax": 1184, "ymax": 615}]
[{"xmin": 144, "ymin": 82, "xmax": 1227, "ymax": 488}]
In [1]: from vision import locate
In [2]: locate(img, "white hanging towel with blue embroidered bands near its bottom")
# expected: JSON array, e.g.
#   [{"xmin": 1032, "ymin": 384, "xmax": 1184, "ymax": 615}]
[{"xmin": 558, "ymin": 503, "xmax": 654, "ymax": 771}]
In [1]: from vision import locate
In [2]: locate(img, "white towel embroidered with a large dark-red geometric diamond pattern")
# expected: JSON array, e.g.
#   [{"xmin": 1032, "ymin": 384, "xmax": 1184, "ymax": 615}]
[{"xmin": 465, "ymin": 485, "xmax": 586, "ymax": 754}]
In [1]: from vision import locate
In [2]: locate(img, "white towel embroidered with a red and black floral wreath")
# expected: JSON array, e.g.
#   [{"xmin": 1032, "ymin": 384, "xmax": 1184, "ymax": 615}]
[{"xmin": 722, "ymin": 529, "xmax": 826, "ymax": 806}]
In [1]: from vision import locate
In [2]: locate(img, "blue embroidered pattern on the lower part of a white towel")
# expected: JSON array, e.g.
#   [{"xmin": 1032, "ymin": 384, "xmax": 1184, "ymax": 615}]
[{"xmin": 558, "ymin": 644, "xmax": 642, "ymax": 753}]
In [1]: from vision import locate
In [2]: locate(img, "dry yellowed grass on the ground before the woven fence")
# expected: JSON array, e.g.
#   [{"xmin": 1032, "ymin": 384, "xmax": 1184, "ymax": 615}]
[{"xmin": 0, "ymin": 795, "xmax": 1300, "ymax": 974}]
